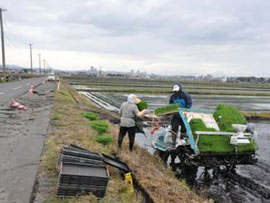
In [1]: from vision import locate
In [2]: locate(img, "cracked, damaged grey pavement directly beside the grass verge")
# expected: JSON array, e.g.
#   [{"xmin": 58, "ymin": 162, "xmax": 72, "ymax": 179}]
[{"xmin": 0, "ymin": 83, "xmax": 54, "ymax": 203}]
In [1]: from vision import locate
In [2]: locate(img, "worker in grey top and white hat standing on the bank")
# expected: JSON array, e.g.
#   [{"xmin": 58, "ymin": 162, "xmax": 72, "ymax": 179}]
[{"xmin": 118, "ymin": 94, "xmax": 148, "ymax": 151}]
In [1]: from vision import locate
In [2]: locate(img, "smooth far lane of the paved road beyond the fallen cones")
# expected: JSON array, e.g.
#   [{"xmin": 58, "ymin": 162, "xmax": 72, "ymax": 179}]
[{"xmin": 0, "ymin": 77, "xmax": 45, "ymax": 105}]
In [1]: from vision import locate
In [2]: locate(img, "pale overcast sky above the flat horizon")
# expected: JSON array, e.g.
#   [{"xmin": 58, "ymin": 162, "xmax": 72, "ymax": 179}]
[{"xmin": 0, "ymin": 0, "xmax": 270, "ymax": 76}]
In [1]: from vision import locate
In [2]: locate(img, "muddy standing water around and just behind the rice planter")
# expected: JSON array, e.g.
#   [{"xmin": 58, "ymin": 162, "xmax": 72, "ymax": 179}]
[{"xmin": 81, "ymin": 93, "xmax": 270, "ymax": 203}]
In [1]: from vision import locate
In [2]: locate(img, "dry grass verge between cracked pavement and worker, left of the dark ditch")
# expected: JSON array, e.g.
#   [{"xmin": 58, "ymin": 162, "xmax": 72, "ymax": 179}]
[{"xmin": 40, "ymin": 81, "xmax": 142, "ymax": 203}]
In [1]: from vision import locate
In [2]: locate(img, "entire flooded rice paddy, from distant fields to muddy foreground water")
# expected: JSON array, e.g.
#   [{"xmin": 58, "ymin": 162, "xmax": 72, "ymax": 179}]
[{"xmin": 65, "ymin": 77, "xmax": 270, "ymax": 203}]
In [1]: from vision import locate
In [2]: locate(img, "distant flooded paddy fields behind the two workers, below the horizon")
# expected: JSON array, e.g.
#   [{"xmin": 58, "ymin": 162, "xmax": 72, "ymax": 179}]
[{"xmin": 65, "ymin": 77, "xmax": 270, "ymax": 112}]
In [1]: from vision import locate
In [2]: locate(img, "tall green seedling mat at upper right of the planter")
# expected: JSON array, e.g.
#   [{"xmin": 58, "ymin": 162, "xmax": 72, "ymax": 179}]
[{"xmin": 214, "ymin": 104, "xmax": 247, "ymax": 132}]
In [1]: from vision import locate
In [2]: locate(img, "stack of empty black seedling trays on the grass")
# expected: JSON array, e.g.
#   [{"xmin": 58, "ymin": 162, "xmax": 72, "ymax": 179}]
[{"xmin": 57, "ymin": 145, "xmax": 109, "ymax": 198}]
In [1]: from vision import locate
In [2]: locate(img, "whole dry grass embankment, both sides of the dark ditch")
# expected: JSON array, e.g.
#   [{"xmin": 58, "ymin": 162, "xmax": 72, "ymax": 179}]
[{"xmin": 41, "ymin": 81, "xmax": 207, "ymax": 203}]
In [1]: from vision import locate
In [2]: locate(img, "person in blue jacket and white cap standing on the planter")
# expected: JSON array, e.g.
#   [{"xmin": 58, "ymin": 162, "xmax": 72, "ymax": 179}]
[{"xmin": 170, "ymin": 83, "xmax": 192, "ymax": 145}]
